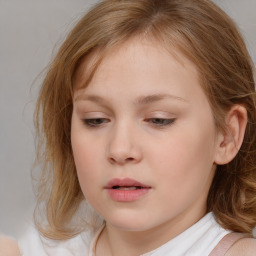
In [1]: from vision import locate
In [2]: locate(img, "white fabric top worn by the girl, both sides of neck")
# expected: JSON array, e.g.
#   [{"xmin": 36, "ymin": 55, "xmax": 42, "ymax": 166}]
[{"xmin": 19, "ymin": 213, "xmax": 230, "ymax": 256}]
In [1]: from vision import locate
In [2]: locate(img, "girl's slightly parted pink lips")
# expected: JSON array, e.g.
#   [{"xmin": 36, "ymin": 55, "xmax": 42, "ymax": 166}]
[{"xmin": 104, "ymin": 178, "xmax": 151, "ymax": 202}]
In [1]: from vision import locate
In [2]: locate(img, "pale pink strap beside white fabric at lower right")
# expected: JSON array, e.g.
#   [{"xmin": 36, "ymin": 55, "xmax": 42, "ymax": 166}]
[{"xmin": 209, "ymin": 232, "xmax": 252, "ymax": 256}]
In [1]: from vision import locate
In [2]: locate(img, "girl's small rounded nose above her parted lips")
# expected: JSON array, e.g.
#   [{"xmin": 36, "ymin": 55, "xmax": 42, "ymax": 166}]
[{"xmin": 107, "ymin": 124, "xmax": 142, "ymax": 165}]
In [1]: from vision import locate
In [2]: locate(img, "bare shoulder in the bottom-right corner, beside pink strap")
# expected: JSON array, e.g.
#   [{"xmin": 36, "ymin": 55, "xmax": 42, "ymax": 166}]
[{"xmin": 225, "ymin": 238, "xmax": 256, "ymax": 256}]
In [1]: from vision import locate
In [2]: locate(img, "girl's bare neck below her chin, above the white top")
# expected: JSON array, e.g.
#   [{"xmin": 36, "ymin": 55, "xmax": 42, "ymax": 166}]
[{"xmin": 96, "ymin": 209, "xmax": 204, "ymax": 256}]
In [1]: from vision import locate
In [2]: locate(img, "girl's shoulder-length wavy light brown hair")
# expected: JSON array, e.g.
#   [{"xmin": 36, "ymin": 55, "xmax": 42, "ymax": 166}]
[{"xmin": 35, "ymin": 0, "xmax": 256, "ymax": 239}]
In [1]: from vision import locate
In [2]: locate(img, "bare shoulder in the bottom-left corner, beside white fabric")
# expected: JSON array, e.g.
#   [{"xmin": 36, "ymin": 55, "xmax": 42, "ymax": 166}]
[{"xmin": 0, "ymin": 235, "xmax": 21, "ymax": 256}]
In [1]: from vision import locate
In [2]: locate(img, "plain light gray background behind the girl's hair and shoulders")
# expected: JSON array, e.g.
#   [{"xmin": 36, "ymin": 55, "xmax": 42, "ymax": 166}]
[{"xmin": 0, "ymin": 0, "xmax": 256, "ymax": 237}]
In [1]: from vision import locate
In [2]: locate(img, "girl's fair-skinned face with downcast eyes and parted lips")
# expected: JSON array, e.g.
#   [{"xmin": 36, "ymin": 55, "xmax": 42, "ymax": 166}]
[{"xmin": 71, "ymin": 39, "xmax": 221, "ymax": 236}]
